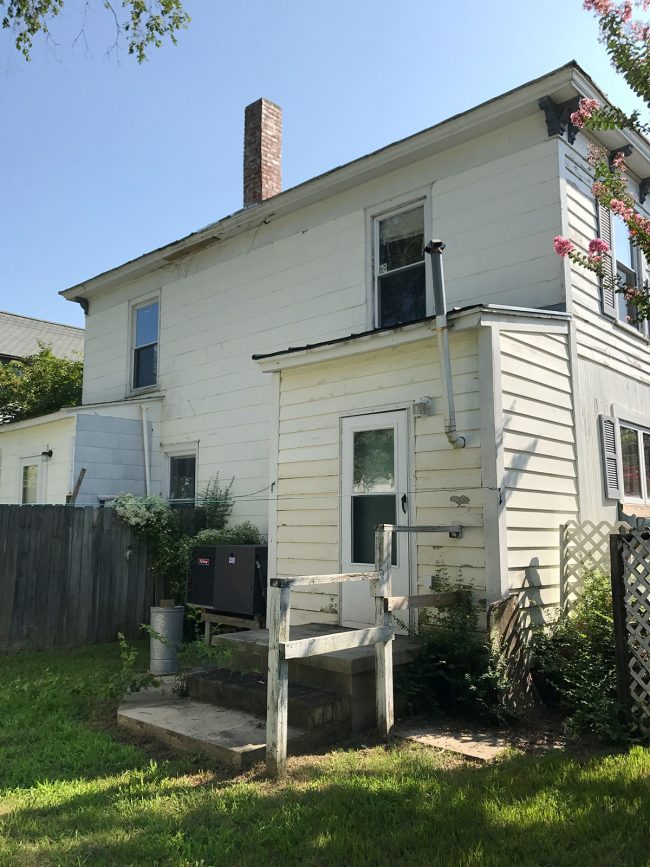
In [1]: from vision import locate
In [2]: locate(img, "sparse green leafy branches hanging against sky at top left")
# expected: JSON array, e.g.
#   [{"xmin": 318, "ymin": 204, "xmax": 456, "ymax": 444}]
[{"xmin": 0, "ymin": 0, "xmax": 190, "ymax": 63}]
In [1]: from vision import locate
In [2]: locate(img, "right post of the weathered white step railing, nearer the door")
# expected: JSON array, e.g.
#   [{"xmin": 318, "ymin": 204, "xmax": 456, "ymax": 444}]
[{"xmin": 375, "ymin": 524, "xmax": 395, "ymax": 738}]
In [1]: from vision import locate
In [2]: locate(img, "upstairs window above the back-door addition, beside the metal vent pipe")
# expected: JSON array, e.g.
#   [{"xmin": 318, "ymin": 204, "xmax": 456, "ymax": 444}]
[{"xmin": 373, "ymin": 203, "xmax": 429, "ymax": 328}]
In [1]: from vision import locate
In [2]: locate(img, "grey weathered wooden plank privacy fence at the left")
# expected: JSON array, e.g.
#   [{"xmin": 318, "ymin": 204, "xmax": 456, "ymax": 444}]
[{"xmin": 0, "ymin": 505, "xmax": 153, "ymax": 651}]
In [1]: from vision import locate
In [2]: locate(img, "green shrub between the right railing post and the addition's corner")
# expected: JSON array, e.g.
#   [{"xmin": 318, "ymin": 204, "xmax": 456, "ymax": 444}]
[{"xmin": 396, "ymin": 575, "xmax": 512, "ymax": 723}]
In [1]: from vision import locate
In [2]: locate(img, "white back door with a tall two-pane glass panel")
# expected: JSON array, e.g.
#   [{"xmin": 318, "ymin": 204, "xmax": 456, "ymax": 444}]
[{"xmin": 341, "ymin": 410, "xmax": 409, "ymax": 626}]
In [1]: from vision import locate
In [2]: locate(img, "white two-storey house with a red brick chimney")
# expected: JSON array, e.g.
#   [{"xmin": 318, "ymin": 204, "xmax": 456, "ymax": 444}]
[{"xmin": 0, "ymin": 63, "xmax": 650, "ymax": 625}]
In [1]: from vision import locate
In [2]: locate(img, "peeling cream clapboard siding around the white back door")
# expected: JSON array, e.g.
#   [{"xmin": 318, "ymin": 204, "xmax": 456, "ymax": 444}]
[{"xmin": 277, "ymin": 333, "xmax": 485, "ymax": 623}]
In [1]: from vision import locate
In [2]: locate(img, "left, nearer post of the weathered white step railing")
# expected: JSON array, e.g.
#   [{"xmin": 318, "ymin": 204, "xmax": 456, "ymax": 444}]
[{"xmin": 266, "ymin": 586, "xmax": 291, "ymax": 779}]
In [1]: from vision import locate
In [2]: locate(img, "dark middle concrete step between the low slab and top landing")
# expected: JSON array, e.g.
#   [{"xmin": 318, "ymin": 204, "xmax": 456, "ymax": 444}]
[{"xmin": 186, "ymin": 668, "xmax": 350, "ymax": 731}]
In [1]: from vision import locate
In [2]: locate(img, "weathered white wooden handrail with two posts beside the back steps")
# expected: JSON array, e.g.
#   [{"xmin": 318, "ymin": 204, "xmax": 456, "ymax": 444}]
[{"xmin": 266, "ymin": 524, "xmax": 463, "ymax": 778}]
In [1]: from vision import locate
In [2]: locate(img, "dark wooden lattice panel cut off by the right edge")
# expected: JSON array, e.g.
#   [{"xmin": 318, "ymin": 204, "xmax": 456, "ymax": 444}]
[{"xmin": 614, "ymin": 530, "xmax": 650, "ymax": 735}]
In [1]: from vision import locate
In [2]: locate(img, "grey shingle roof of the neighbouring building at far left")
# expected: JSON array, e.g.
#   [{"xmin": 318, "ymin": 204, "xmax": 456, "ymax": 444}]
[{"xmin": 0, "ymin": 311, "xmax": 84, "ymax": 359}]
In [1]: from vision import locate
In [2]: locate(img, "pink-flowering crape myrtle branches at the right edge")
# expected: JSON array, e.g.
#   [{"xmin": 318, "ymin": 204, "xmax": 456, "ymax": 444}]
[{"xmin": 554, "ymin": 0, "xmax": 650, "ymax": 322}]
